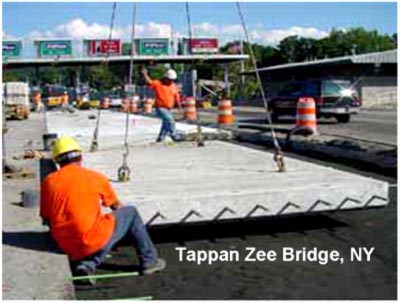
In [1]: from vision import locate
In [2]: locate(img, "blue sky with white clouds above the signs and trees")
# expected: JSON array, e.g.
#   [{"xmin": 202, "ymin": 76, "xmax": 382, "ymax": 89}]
[{"xmin": 2, "ymin": 2, "xmax": 397, "ymax": 56}]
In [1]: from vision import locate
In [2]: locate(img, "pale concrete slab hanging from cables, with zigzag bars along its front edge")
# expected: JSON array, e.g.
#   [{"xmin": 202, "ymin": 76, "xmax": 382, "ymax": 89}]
[{"xmin": 84, "ymin": 141, "xmax": 388, "ymax": 225}]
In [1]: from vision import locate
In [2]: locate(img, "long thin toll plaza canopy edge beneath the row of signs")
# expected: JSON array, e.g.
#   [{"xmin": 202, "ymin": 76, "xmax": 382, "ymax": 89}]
[{"xmin": 3, "ymin": 54, "xmax": 249, "ymax": 68}]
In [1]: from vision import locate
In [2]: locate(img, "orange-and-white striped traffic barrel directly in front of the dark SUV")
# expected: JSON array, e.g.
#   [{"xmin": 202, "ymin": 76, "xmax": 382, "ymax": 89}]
[{"xmin": 296, "ymin": 98, "xmax": 317, "ymax": 134}]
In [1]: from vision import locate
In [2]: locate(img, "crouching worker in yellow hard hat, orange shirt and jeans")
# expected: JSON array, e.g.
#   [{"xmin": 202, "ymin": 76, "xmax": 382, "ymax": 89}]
[{"xmin": 40, "ymin": 137, "xmax": 166, "ymax": 284}]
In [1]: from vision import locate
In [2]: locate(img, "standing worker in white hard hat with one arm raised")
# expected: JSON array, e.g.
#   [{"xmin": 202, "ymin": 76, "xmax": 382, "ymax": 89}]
[{"xmin": 142, "ymin": 68, "xmax": 182, "ymax": 142}]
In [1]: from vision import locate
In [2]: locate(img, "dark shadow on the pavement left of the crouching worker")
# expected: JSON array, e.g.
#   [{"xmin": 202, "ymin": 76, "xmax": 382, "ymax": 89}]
[{"xmin": 3, "ymin": 231, "xmax": 63, "ymax": 254}]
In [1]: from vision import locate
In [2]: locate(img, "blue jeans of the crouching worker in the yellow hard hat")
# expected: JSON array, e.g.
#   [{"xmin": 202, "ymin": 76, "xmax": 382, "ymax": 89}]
[{"xmin": 71, "ymin": 206, "xmax": 157, "ymax": 270}]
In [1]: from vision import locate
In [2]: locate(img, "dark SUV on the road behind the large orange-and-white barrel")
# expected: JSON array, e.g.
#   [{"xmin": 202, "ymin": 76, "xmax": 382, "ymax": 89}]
[{"xmin": 268, "ymin": 79, "xmax": 361, "ymax": 123}]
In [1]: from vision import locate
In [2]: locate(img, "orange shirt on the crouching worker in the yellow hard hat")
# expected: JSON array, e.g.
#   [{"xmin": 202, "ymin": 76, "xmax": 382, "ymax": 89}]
[{"xmin": 40, "ymin": 164, "xmax": 116, "ymax": 259}]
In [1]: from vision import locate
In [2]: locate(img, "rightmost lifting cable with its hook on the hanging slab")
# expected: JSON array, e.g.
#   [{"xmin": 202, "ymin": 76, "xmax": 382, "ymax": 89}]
[{"xmin": 236, "ymin": 2, "xmax": 286, "ymax": 172}]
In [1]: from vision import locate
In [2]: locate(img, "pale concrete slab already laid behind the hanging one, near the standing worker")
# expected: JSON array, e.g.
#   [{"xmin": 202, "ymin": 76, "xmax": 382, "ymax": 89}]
[{"xmin": 46, "ymin": 110, "xmax": 226, "ymax": 151}]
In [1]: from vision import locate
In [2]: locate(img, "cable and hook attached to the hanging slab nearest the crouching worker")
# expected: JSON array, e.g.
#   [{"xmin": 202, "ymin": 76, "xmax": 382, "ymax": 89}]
[{"xmin": 118, "ymin": 2, "xmax": 137, "ymax": 182}]
